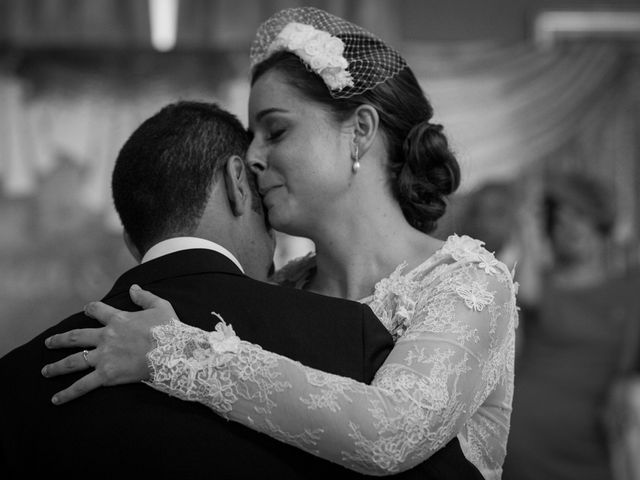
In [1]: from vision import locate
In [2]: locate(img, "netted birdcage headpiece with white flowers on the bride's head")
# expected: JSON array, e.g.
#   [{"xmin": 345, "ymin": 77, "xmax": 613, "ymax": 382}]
[{"xmin": 250, "ymin": 7, "xmax": 407, "ymax": 98}]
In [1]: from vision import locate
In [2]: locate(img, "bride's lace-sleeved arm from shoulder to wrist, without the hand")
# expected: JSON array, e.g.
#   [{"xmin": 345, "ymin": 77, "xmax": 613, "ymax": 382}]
[{"xmin": 154, "ymin": 266, "xmax": 514, "ymax": 475}]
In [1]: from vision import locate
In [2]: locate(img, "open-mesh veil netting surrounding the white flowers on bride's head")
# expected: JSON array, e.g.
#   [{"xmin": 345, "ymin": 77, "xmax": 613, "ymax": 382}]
[{"xmin": 250, "ymin": 7, "xmax": 407, "ymax": 98}]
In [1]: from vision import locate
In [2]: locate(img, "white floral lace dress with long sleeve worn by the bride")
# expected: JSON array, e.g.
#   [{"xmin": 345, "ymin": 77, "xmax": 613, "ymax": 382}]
[{"xmin": 149, "ymin": 236, "xmax": 517, "ymax": 479}]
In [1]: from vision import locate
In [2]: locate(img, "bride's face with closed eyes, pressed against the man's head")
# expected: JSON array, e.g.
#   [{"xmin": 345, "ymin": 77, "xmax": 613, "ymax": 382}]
[{"xmin": 247, "ymin": 70, "xmax": 353, "ymax": 238}]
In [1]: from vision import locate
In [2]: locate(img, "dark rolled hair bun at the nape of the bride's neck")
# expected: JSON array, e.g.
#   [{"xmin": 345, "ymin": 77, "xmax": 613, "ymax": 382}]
[{"xmin": 397, "ymin": 119, "xmax": 460, "ymax": 232}]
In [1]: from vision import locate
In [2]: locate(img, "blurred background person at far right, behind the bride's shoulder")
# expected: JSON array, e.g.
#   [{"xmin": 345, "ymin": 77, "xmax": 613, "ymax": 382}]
[{"xmin": 503, "ymin": 173, "xmax": 640, "ymax": 480}]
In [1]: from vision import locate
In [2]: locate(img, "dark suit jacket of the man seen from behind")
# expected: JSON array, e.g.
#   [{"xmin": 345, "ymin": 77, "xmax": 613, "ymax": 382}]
[{"xmin": 0, "ymin": 249, "xmax": 482, "ymax": 480}]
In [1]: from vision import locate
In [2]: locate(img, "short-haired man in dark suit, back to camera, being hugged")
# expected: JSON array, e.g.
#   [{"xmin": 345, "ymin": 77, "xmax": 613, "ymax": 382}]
[{"xmin": 0, "ymin": 102, "xmax": 482, "ymax": 480}]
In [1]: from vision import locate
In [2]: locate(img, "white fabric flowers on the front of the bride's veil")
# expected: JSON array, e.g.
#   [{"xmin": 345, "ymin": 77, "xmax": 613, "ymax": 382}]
[{"xmin": 267, "ymin": 22, "xmax": 353, "ymax": 90}]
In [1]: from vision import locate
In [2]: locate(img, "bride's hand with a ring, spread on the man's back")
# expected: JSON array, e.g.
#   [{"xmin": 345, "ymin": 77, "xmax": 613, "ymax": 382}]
[{"xmin": 42, "ymin": 285, "xmax": 178, "ymax": 405}]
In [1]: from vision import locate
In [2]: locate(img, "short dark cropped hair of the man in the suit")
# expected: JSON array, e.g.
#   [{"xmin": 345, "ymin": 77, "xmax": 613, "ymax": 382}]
[{"xmin": 111, "ymin": 101, "xmax": 251, "ymax": 254}]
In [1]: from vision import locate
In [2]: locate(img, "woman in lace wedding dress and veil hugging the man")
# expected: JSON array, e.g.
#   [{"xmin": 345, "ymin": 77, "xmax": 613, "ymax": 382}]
[{"xmin": 42, "ymin": 8, "xmax": 517, "ymax": 479}]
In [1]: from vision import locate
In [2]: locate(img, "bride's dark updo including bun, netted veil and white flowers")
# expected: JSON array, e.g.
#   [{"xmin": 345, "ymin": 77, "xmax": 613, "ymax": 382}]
[{"xmin": 251, "ymin": 7, "xmax": 460, "ymax": 233}]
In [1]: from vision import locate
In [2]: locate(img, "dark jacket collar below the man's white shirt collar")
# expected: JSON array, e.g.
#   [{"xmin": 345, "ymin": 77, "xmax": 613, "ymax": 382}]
[{"xmin": 102, "ymin": 248, "xmax": 243, "ymax": 301}]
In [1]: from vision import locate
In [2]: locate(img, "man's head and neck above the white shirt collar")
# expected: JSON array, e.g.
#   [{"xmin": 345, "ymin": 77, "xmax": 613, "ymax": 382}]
[{"xmin": 112, "ymin": 101, "xmax": 273, "ymax": 282}]
